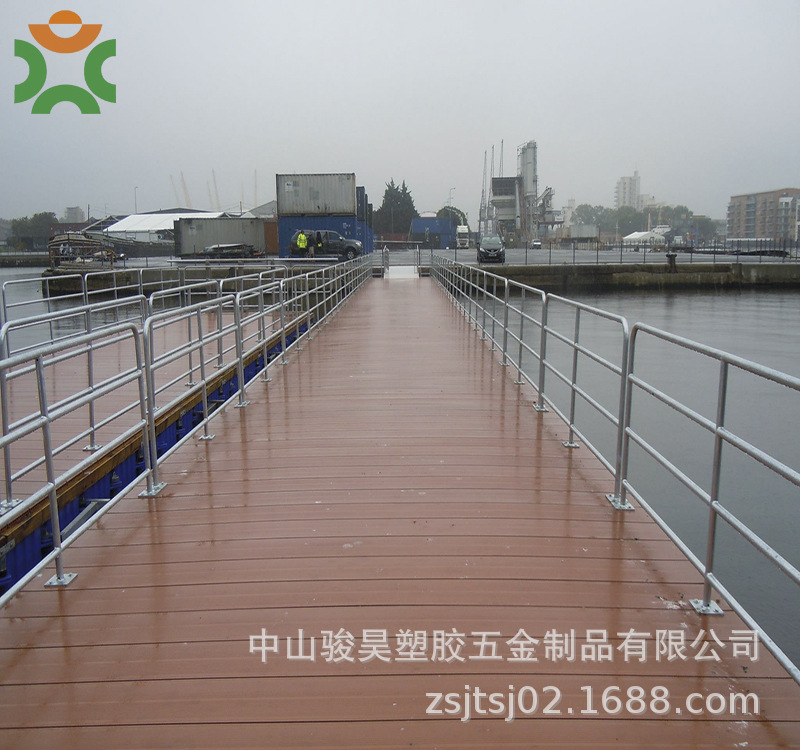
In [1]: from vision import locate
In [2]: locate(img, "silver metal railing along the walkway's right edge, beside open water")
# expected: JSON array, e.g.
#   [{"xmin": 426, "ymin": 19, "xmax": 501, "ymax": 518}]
[{"xmin": 431, "ymin": 256, "xmax": 800, "ymax": 683}]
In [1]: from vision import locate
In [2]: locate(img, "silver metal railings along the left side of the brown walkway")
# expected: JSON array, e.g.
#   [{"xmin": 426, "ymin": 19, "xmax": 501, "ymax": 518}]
[{"xmin": 0, "ymin": 258, "xmax": 372, "ymax": 607}]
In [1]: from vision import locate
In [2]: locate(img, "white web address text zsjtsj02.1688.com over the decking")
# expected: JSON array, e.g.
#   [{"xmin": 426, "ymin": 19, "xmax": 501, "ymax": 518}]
[{"xmin": 425, "ymin": 685, "xmax": 760, "ymax": 721}]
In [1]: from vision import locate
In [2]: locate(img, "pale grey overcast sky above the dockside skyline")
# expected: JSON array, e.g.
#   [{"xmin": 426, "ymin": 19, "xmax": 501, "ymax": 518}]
[{"xmin": 0, "ymin": 0, "xmax": 800, "ymax": 226}]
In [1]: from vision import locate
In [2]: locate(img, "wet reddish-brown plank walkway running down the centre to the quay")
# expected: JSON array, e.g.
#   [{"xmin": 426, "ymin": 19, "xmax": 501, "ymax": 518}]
[{"xmin": 0, "ymin": 276, "xmax": 800, "ymax": 750}]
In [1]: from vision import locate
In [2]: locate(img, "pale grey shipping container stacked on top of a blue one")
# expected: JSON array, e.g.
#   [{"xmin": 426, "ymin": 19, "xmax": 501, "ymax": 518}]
[{"xmin": 275, "ymin": 173, "xmax": 357, "ymax": 216}]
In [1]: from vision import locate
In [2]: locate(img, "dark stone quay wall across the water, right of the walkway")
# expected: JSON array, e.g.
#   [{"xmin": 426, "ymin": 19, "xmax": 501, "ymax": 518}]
[{"xmin": 481, "ymin": 263, "xmax": 800, "ymax": 294}]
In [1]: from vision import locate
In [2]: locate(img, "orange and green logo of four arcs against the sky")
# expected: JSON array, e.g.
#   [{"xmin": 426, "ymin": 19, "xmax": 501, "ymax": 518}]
[{"xmin": 14, "ymin": 10, "xmax": 117, "ymax": 115}]
